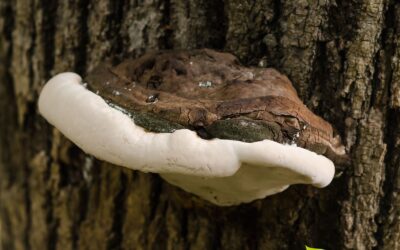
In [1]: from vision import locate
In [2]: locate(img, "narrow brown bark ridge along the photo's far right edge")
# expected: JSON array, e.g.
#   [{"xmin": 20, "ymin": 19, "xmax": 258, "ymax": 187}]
[{"xmin": 376, "ymin": 1, "xmax": 400, "ymax": 249}]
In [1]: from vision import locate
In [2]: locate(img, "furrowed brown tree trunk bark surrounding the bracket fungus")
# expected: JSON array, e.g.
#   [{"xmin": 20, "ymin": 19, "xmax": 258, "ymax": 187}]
[{"xmin": 0, "ymin": 0, "xmax": 400, "ymax": 250}]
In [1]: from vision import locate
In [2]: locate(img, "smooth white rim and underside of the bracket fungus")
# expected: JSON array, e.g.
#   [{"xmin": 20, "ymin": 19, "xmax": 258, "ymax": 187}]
[{"xmin": 39, "ymin": 73, "xmax": 335, "ymax": 205}]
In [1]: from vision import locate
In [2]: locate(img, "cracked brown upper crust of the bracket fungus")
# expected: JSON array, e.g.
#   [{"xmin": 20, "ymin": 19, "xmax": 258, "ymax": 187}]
[{"xmin": 85, "ymin": 49, "xmax": 346, "ymax": 163}]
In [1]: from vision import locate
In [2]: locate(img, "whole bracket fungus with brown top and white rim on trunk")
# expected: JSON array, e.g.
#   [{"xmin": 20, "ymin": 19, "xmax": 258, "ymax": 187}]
[{"xmin": 39, "ymin": 49, "xmax": 345, "ymax": 206}]
